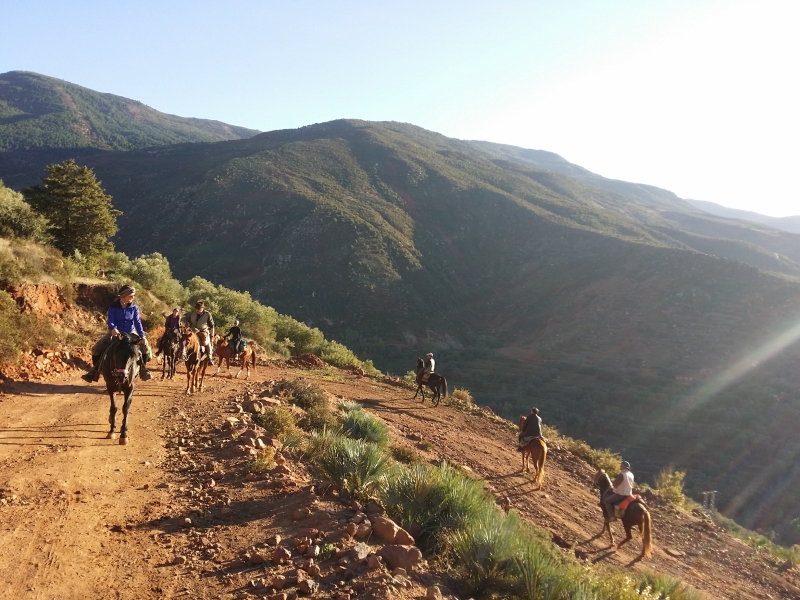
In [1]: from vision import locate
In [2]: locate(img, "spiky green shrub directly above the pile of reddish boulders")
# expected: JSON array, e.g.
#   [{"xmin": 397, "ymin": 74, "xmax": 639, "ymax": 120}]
[{"xmin": 317, "ymin": 436, "xmax": 389, "ymax": 499}]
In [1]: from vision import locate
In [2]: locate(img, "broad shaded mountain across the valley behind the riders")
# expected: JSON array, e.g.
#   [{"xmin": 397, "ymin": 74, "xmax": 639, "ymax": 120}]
[{"xmin": 0, "ymin": 74, "xmax": 800, "ymax": 535}]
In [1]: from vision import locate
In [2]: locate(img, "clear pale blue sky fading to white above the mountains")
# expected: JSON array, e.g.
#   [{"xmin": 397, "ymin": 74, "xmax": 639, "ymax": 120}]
[{"xmin": 0, "ymin": 0, "xmax": 800, "ymax": 216}]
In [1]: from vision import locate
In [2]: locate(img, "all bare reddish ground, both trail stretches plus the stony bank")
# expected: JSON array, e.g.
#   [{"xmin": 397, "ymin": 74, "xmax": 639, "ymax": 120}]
[{"xmin": 0, "ymin": 356, "xmax": 800, "ymax": 599}]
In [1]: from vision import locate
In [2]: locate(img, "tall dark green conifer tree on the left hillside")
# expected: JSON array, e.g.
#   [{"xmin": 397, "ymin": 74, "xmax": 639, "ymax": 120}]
[{"xmin": 22, "ymin": 159, "xmax": 122, "ymax": 258}]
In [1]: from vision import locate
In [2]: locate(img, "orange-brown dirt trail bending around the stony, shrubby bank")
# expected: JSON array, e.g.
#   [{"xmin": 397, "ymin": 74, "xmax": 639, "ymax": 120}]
[{"xmin": 0, "ymin": 367, "xmax": 800, "ymax": 599}]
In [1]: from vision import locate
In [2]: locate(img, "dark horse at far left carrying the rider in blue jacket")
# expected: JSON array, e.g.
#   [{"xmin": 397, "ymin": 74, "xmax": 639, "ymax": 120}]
[{"xmin": 100, "ymin": 333, "xmax": 142, "ymax": 445}]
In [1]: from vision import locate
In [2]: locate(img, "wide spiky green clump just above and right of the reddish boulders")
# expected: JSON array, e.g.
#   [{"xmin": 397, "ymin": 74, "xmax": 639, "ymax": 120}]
[{"xmin": 381, "ymin": 463, "xmax": 494, "ymax": 550}]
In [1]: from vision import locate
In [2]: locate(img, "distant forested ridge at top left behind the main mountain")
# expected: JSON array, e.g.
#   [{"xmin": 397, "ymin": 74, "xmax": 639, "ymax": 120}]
[{"xmin": 0, "ymin": 71, "xmax": 259, "ymax": 152}]
